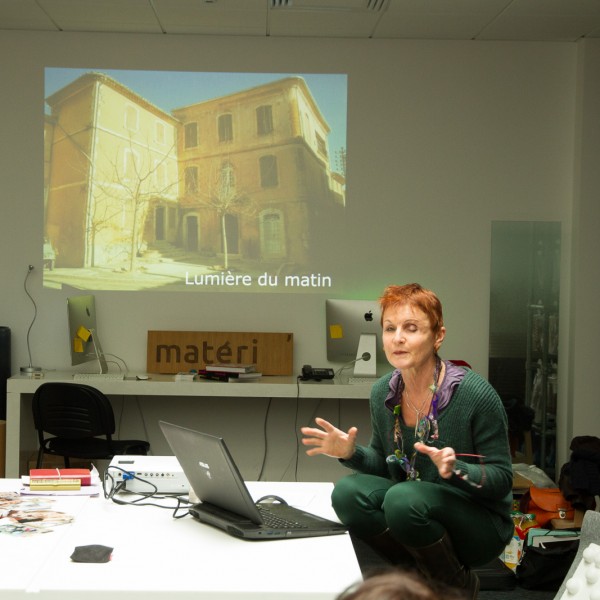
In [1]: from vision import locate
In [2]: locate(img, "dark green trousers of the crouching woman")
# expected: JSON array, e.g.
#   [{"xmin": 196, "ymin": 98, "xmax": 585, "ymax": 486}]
[{"xmin": 331, "ymin": 474, "xmax": 506, "ymax": 566}]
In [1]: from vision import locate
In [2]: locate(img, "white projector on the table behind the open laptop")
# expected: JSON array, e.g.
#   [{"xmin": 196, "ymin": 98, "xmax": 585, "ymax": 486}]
[{"xmin": 108, "ymin": 455, "xmax": 190, "ymax": 494}]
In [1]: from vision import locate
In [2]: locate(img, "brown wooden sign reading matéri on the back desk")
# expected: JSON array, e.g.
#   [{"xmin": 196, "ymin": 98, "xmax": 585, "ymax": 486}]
[{"xmin": 146, "ymin": 331, "xmax": 294, "ymax": 375}]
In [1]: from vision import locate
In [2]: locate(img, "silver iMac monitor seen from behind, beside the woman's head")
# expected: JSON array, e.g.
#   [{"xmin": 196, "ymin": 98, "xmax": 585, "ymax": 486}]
[{"xmin": 325, "ymin": 299, "xmax": 385, "ymax": 377}]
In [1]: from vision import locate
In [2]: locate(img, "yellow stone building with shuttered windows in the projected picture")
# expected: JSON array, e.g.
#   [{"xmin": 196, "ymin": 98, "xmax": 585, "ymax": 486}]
[{"xmin": 45, "ymin": 73, "xmax": 345, "ymax": 273}]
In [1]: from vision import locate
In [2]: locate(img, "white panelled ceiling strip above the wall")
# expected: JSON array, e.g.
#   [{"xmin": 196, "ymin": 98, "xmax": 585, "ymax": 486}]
[{"xmin": 0, "ymin": 0, "xmax": 600, "ymax": 42}]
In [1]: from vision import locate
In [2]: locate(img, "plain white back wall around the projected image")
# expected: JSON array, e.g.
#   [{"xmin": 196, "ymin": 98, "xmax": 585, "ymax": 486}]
[{"xmin": 0, "ymin": 32, "xmax": 599, "ymax": 479}]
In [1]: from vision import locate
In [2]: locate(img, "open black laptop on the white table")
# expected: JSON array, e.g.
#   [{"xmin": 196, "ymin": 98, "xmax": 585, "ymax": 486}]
[{"xmin": 159, "ymin": 421, "xmax": 347, "ymax": 540}]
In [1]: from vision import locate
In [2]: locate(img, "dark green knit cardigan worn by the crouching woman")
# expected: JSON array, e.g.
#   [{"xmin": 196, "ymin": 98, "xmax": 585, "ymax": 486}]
[{"xmin": 341, "ymin": 369, "xmax": 514, "ymax": 543}]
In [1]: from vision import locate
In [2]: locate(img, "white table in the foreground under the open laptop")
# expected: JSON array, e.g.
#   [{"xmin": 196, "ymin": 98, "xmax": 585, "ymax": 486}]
[{"xmin": 0, "ymin": 480, "xmax": 361, "ymax": 600}]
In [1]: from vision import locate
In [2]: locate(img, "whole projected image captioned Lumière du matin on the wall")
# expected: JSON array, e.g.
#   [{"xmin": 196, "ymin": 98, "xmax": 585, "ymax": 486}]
[{"xmin": 44, "ymin": 68, "xmax": 347, "ymax": 292}]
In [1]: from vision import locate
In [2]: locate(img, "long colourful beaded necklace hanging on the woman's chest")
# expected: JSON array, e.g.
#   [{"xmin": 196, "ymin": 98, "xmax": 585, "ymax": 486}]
[{"xmin": 386, "ymin": 355, "xmax": 442, "ymax": 481}]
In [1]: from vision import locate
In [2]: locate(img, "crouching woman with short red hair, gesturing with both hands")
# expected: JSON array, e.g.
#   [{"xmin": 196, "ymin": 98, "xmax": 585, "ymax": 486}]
[{"xmin": 302, "ymin": 283, "xmax": 513, "ymax": 598}]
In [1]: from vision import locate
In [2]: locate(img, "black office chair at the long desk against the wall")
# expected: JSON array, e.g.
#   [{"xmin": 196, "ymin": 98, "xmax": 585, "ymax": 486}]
[{"xmin": 32, "ymin": 382, "xmax": 150, "ymax": 469}]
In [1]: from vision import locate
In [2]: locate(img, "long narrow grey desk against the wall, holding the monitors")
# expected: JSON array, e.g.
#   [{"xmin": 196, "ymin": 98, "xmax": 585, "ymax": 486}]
[{"xmin": 6, "ymin": 371, "xmax": 371, "ymax": 477}]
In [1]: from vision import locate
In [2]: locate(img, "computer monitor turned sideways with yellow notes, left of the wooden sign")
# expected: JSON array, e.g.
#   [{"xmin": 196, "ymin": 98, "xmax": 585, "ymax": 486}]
[{"xmin": 67, "ymin": 295, "xmax": 108, "ymax": 373}]
